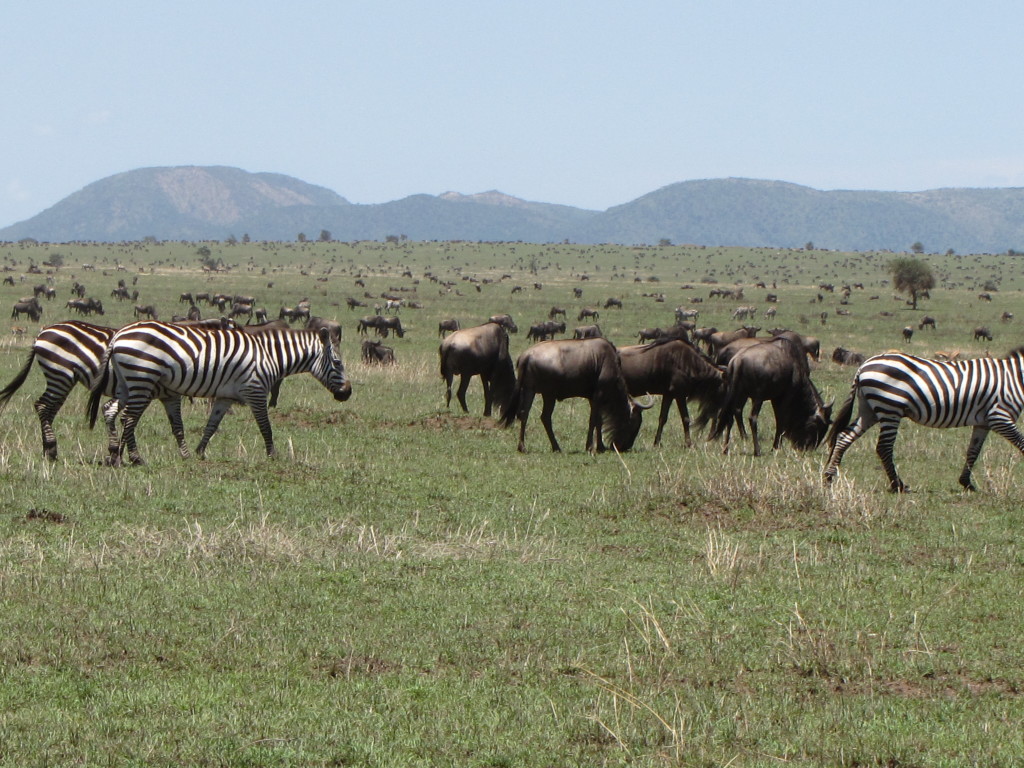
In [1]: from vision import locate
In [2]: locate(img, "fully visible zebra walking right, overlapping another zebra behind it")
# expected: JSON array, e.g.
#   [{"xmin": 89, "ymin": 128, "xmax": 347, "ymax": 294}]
[{"xmin": 89, "ymin": 322, "xmax": 352, "ymax": 465}]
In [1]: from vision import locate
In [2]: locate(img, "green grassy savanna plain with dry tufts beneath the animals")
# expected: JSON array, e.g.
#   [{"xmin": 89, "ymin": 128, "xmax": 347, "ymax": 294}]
[{"xmin": 0, "ymin": 242, "xmax": 1024, "ymax": 766}]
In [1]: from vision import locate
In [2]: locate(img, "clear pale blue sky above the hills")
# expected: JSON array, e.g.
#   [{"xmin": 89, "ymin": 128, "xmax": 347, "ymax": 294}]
[{"xmin": 8, "ymin": 0, "xmax": 1024, "ymax": 226}]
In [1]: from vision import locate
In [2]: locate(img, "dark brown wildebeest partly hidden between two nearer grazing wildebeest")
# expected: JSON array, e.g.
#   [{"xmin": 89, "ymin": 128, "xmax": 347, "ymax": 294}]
[{"xmin": 618, "ymin": 339, "xmax": 725, "ymax": 447}]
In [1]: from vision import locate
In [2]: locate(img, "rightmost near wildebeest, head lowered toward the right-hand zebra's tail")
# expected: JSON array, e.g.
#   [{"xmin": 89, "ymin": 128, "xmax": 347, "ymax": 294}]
[{"xmin": 711, "ymin": 337, "xmax": 831, "ymax": 456}]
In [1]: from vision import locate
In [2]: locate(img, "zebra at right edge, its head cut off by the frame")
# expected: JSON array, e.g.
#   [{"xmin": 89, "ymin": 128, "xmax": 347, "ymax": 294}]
[{"xmin": 824, "ymin": 347, "xmax": 1024, "ymax": 493}]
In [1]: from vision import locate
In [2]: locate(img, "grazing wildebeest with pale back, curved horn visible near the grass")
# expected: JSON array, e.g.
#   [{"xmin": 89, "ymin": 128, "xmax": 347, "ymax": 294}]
[{"xmin": 502, "ymin": 339, "xmax": 649, "ymax": 453}]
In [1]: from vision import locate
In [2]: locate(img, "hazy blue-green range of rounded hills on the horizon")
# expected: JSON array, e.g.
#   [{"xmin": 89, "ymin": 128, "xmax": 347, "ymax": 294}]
[{"xmin": 6, "ymin": 166, "xmax": 1024, "ymax": 253}]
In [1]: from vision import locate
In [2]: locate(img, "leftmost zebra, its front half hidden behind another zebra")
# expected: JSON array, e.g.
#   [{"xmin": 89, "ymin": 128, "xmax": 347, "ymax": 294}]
[{"xmin": 0, "ymin": 319, "xmax": 238, "ymax": 461}]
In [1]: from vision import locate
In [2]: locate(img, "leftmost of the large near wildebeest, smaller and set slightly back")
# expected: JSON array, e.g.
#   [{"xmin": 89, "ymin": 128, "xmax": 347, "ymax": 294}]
[{"xmin": 437, "ymin": 323, "xmax": 515, "ymax": 416}]
